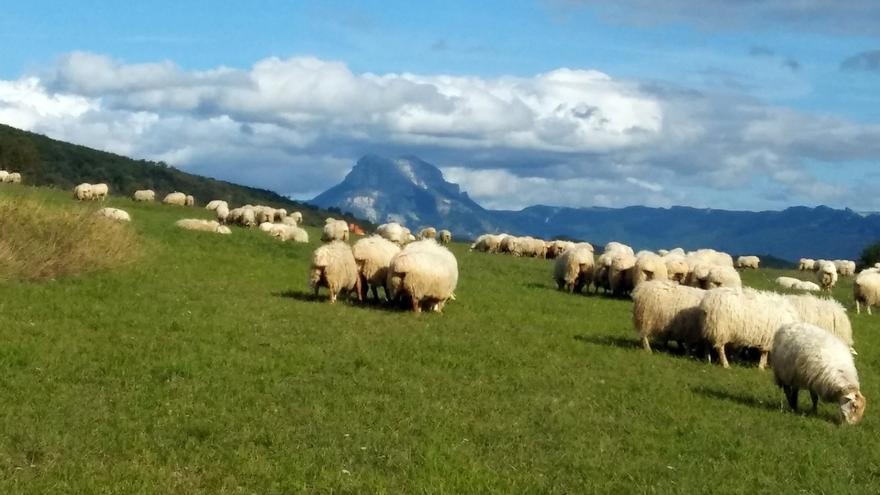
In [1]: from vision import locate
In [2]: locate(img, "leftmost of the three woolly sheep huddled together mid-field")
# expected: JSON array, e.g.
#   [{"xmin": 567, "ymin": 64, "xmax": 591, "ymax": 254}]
[{"xmin": 309, "ymin": 240, "xmax": 363, "ymax": 303}]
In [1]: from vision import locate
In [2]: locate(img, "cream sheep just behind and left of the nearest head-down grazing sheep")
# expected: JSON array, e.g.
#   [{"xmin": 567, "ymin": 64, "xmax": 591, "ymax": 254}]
[{"xmin": 700, "ymin": 287, "xmax": 799, "ymax": 369}]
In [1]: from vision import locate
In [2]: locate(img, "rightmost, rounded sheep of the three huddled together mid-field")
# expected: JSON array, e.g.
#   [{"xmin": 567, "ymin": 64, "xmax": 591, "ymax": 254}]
[{"xmin": 387, "ymin": 239, "xmax": 458, "ymax": 313}]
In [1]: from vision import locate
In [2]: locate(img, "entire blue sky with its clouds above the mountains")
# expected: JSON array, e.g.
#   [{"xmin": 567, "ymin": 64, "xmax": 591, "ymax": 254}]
[{"xmin": 0, "ymin": 0, "xmax": 880, "ymax": 211}]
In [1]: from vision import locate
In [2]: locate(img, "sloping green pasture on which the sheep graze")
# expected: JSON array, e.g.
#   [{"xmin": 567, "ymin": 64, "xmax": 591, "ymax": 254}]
[{"xmin": 0, "ymin": 185, "xmax": 880, "ymax": 494}]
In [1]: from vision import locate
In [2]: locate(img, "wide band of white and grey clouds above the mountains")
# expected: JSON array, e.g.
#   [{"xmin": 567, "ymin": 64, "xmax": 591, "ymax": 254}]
[{"xmin": 0, "ymin": 52, "xmax": 880, "ymax": 208}]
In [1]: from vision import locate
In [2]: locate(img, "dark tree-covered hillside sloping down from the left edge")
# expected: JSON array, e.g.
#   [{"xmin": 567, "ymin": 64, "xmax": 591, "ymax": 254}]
[{"xmin": 0, "ymin": 124, "xmax": 364, "ymax": 225}]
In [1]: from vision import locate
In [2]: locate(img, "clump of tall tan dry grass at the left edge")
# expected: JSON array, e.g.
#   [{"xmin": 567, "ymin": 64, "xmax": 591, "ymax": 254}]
[{"xmin": 0, "ymin": 198, "xmax": 140, "ymax": 280}]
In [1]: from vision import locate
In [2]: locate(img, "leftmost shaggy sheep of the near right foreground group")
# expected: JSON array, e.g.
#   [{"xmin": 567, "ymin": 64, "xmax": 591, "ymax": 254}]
[{"xmin": 632, "ymin": 280, "xmax": 706, "ymax": 352}]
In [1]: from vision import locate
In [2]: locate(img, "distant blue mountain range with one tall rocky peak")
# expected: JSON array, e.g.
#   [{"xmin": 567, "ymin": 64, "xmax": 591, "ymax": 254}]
[{"xmin": 311, "ymin": 155, "xmax": 880, "ymax": 260}]
